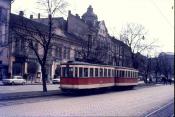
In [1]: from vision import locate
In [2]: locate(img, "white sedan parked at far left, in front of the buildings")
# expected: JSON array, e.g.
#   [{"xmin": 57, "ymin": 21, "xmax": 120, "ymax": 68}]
[{"xmin": 2, "ymin": 76, "xmax": 26, "ymax": 85}]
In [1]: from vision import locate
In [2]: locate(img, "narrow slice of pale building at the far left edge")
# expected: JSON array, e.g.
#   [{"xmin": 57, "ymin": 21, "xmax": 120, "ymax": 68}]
[{"xmin": 0, "ymin": 0, "xmax": 11, "ymax": 80}]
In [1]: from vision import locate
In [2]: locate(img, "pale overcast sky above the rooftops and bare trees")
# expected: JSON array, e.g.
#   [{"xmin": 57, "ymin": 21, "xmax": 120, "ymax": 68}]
[{"xmin": 12, "ymin": 0, "xmax": 174, "ymax": 53}]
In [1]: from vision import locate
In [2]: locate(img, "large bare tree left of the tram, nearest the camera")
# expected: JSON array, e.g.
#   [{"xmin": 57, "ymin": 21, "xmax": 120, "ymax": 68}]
[{"xmin": 10, "ymin": 0, "xmax": 67, "ymax": 92}]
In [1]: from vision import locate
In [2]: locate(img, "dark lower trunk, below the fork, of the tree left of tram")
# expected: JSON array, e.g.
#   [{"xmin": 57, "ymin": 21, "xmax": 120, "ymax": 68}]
[{"xmin": 41, "ymin": 66, "xmax": 47, "ymax": 92}]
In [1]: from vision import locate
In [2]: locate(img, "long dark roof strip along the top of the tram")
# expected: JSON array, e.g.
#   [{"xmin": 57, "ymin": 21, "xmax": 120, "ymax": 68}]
[{"xmin": 62, "ymin": 61, "xmax": 136, "ymax": 70}]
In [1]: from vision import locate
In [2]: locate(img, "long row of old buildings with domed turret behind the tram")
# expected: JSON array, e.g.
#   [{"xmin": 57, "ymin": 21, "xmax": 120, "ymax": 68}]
[{"xmin": 0, "ymin": 6, "xmax": 132, "ymax": 81}]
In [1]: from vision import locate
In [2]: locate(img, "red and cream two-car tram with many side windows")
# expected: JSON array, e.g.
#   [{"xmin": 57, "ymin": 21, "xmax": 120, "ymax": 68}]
[{"xmin": 60, "ymin": 62, "xmax": 138, "ymax": 91}]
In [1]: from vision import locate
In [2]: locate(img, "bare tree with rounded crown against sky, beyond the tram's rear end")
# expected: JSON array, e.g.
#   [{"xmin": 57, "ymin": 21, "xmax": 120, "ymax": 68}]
[{"xmin": 120, "ymin": 23, "xmax": 155, "ymax": 68}]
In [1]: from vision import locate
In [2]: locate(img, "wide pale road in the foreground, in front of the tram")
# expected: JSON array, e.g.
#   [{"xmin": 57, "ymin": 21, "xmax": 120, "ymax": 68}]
[{"xmin": 0, "ymin": 85, "xmax": 174, "ymax": 117}]
